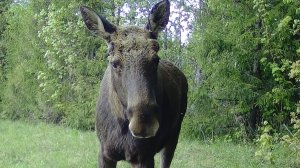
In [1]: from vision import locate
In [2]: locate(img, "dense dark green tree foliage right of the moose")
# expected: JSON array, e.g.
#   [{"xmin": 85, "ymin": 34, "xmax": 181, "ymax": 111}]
[{"xmin": 187, "ymin": 0, "xmax": 300, "ymax": 139}]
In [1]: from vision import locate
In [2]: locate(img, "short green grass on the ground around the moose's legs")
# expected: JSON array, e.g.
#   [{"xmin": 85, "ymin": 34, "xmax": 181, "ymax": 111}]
[{"xmin": 0, "ymin": 120, "xmax": 297, "ymax": 168}]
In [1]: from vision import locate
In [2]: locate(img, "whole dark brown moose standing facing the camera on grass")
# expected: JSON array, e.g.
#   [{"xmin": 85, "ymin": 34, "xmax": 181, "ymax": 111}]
[{"xmin": 80, "ymin": 0, "xmax": 188, "ymax": 168}]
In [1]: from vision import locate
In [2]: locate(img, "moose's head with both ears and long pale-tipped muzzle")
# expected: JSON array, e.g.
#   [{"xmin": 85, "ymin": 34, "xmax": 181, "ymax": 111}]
[{"xmin": 80, "ymin": 0, "xmax": 170, "ymax": 138}]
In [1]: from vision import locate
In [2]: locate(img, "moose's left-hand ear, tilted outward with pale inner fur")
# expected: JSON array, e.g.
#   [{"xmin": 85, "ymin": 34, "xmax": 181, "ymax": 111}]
[{"xmin": 80, "ymin": 6, "xmax": 117, "ymax": 40}]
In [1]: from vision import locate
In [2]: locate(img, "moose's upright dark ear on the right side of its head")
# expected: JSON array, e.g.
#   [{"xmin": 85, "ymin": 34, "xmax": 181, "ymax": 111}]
[{"xmin": 146, "ymin": 0, "xmax": 170, "ymax": 37}]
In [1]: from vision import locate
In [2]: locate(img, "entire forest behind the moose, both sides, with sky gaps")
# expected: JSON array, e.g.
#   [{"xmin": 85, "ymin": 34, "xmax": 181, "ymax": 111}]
[{"xmin": 0, "ymin": 0, "xmax": 300, "ymax": 165}]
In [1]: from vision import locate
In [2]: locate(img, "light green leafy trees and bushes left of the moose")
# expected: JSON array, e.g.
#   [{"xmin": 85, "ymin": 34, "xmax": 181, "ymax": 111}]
[{"xmin": 0, "ymin": 1, "xmax": 106, "ymax": 129}]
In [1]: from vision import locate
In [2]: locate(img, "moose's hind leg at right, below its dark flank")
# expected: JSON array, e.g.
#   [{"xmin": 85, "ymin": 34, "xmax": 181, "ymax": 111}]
[{"xmin": 160, "ymin": 132, "xmax": 179, "ymax": 168}]
